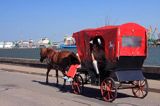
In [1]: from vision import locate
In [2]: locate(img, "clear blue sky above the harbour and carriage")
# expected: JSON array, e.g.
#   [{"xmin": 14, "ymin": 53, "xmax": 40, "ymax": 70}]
[{"xmin": 0, "ymin": 0, "xmax": 160, "ymax": 42}]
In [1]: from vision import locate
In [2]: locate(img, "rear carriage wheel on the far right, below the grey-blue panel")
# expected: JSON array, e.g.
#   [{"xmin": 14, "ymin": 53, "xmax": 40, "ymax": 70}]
[{"xmin": 132, "ymin": 79, "xmax": 148, "ymax": 98}]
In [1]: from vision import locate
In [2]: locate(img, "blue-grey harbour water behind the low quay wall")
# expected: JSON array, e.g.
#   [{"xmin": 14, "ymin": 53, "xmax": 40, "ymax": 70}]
[{"xmin": 0, "ymin": 47, "xmax": 160, "ymax": 66}]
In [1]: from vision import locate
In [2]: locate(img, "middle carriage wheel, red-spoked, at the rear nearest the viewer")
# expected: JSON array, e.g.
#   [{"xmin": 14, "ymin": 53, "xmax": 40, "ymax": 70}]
[{"xmin": 100, "ymin": 78, "xmax": 117, "ymax": 102}]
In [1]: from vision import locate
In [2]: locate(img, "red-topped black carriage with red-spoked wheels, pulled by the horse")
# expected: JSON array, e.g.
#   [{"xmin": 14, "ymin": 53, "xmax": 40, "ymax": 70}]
[{"xmin": 72, "ymin": 23, "xmax": 148, "ymax": 102}]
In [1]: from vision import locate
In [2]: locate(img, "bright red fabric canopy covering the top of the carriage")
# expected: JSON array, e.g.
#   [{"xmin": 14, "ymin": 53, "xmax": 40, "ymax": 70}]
[{"xmin": 73, "ymin": 23, "xmax": 147, "ymax": 61}]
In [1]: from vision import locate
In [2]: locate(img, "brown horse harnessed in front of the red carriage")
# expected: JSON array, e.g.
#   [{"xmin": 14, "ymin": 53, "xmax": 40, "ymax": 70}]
[{"xmin": 40, "ymin": 48, "xmax": 80, "ymax": 86}]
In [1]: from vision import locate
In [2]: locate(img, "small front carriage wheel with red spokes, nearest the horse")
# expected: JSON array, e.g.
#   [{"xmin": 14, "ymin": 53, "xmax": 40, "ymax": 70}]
[{"xmin": 72, "ymin": 74, "xmax": 84, "ymax": 94}]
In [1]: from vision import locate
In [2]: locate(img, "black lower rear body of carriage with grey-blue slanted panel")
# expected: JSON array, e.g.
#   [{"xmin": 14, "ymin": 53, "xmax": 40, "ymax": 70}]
[{"xmin": 112, "ymin": 56, "xmax": 146, "ymax": 82}]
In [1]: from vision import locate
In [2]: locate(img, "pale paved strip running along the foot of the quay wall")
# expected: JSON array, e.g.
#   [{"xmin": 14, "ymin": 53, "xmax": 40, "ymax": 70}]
[{"xmin": 0, "ymin": 63, "xmax": 160, "ymax": 93}]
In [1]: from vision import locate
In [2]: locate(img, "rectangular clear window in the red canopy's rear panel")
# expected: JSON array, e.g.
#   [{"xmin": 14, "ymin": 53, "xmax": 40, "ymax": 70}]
[{"xmin": 122, "ymin": 36, "xmax": 142, "ymax": 47}]
